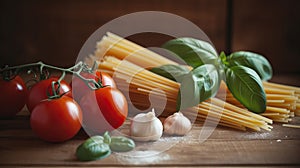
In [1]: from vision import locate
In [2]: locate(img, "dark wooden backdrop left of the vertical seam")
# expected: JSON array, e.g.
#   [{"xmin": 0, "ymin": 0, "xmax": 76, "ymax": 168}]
[{"xmin": 0, "ymin": 0, "xmax": 226, "ymax": 66}]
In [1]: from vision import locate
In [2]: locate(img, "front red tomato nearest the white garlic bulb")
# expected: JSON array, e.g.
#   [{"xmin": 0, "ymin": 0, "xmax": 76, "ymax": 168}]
[{"xmin": 80, "ymin": 87, "xmax": 128, "ymax": 134}]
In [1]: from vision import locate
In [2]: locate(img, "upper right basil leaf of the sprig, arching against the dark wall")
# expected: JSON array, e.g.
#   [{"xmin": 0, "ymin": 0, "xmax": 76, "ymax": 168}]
[{"xmin": 226, "ymin": 51, "xmax": 273, "ymax": 80}]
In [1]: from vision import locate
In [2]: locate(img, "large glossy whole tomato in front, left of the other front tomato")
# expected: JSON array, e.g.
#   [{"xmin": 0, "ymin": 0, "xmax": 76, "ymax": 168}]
[{"xmin": 30, "ymin": 96, "xmax": 82, "ymax": 142}]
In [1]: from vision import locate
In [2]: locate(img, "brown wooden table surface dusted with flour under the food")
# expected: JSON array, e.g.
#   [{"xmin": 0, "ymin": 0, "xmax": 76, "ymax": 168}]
[{"xmin": 0, "ymin": 111, "xmax": 300, "ymax": 167}]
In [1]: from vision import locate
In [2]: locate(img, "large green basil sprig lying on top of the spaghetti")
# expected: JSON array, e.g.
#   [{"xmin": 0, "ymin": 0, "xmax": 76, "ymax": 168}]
[{"xmin": 152, "ymin": 37, "xmax": 272, "ymax": 113}]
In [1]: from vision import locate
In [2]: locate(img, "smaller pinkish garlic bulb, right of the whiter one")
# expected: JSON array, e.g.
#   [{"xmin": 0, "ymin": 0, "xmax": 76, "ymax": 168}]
[{"xmin": 164, "ymin": 112, "xmax": 192, "ymax": 135}]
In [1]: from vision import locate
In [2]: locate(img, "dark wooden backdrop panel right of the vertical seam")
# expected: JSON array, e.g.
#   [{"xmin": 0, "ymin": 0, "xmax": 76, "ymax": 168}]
[{"xmin": 232, "ymin": 0, "xmax": 300, "ymax": 74}]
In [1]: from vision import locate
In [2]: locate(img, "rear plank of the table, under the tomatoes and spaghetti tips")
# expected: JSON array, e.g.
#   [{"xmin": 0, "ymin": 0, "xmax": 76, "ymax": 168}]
[{"xmin": 0, "ymin": 116, "xmax": 300, "ymax": 141}]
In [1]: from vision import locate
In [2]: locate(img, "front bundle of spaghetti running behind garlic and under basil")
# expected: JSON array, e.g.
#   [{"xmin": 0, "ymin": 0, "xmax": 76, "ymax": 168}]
[{"xmin": 95, "ymin": 56, "xmax": 272, "ymax": 131}]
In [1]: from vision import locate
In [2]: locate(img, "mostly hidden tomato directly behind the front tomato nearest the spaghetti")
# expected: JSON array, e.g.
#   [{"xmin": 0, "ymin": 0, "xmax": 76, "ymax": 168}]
[{"xmin": 71, "ymin": 71, "xmax": 117, "ymax": 102}]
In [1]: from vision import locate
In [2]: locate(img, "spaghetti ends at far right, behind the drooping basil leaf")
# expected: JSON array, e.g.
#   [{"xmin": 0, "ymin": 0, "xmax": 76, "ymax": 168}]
[{"xmin": 217, "ymin": 82, "xmax": 299, "ymax": 123}]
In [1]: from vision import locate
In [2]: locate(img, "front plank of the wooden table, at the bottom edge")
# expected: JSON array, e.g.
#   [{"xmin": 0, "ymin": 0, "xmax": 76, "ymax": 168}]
[{"xmin": 0, "ymin": 138, "xmax": 300, "ymax": 167}]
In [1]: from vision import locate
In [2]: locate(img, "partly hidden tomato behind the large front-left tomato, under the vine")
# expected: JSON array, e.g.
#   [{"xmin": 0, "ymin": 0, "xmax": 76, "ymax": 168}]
[{"xmin": 26, "ymin": 77, "xmax": 72, "ymax": 112}]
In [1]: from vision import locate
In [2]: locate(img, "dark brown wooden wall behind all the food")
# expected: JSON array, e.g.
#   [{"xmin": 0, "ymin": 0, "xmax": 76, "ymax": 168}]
[{"xmin": 0, "ymin": 0, "xmax": 300, "ymax": 84}]
